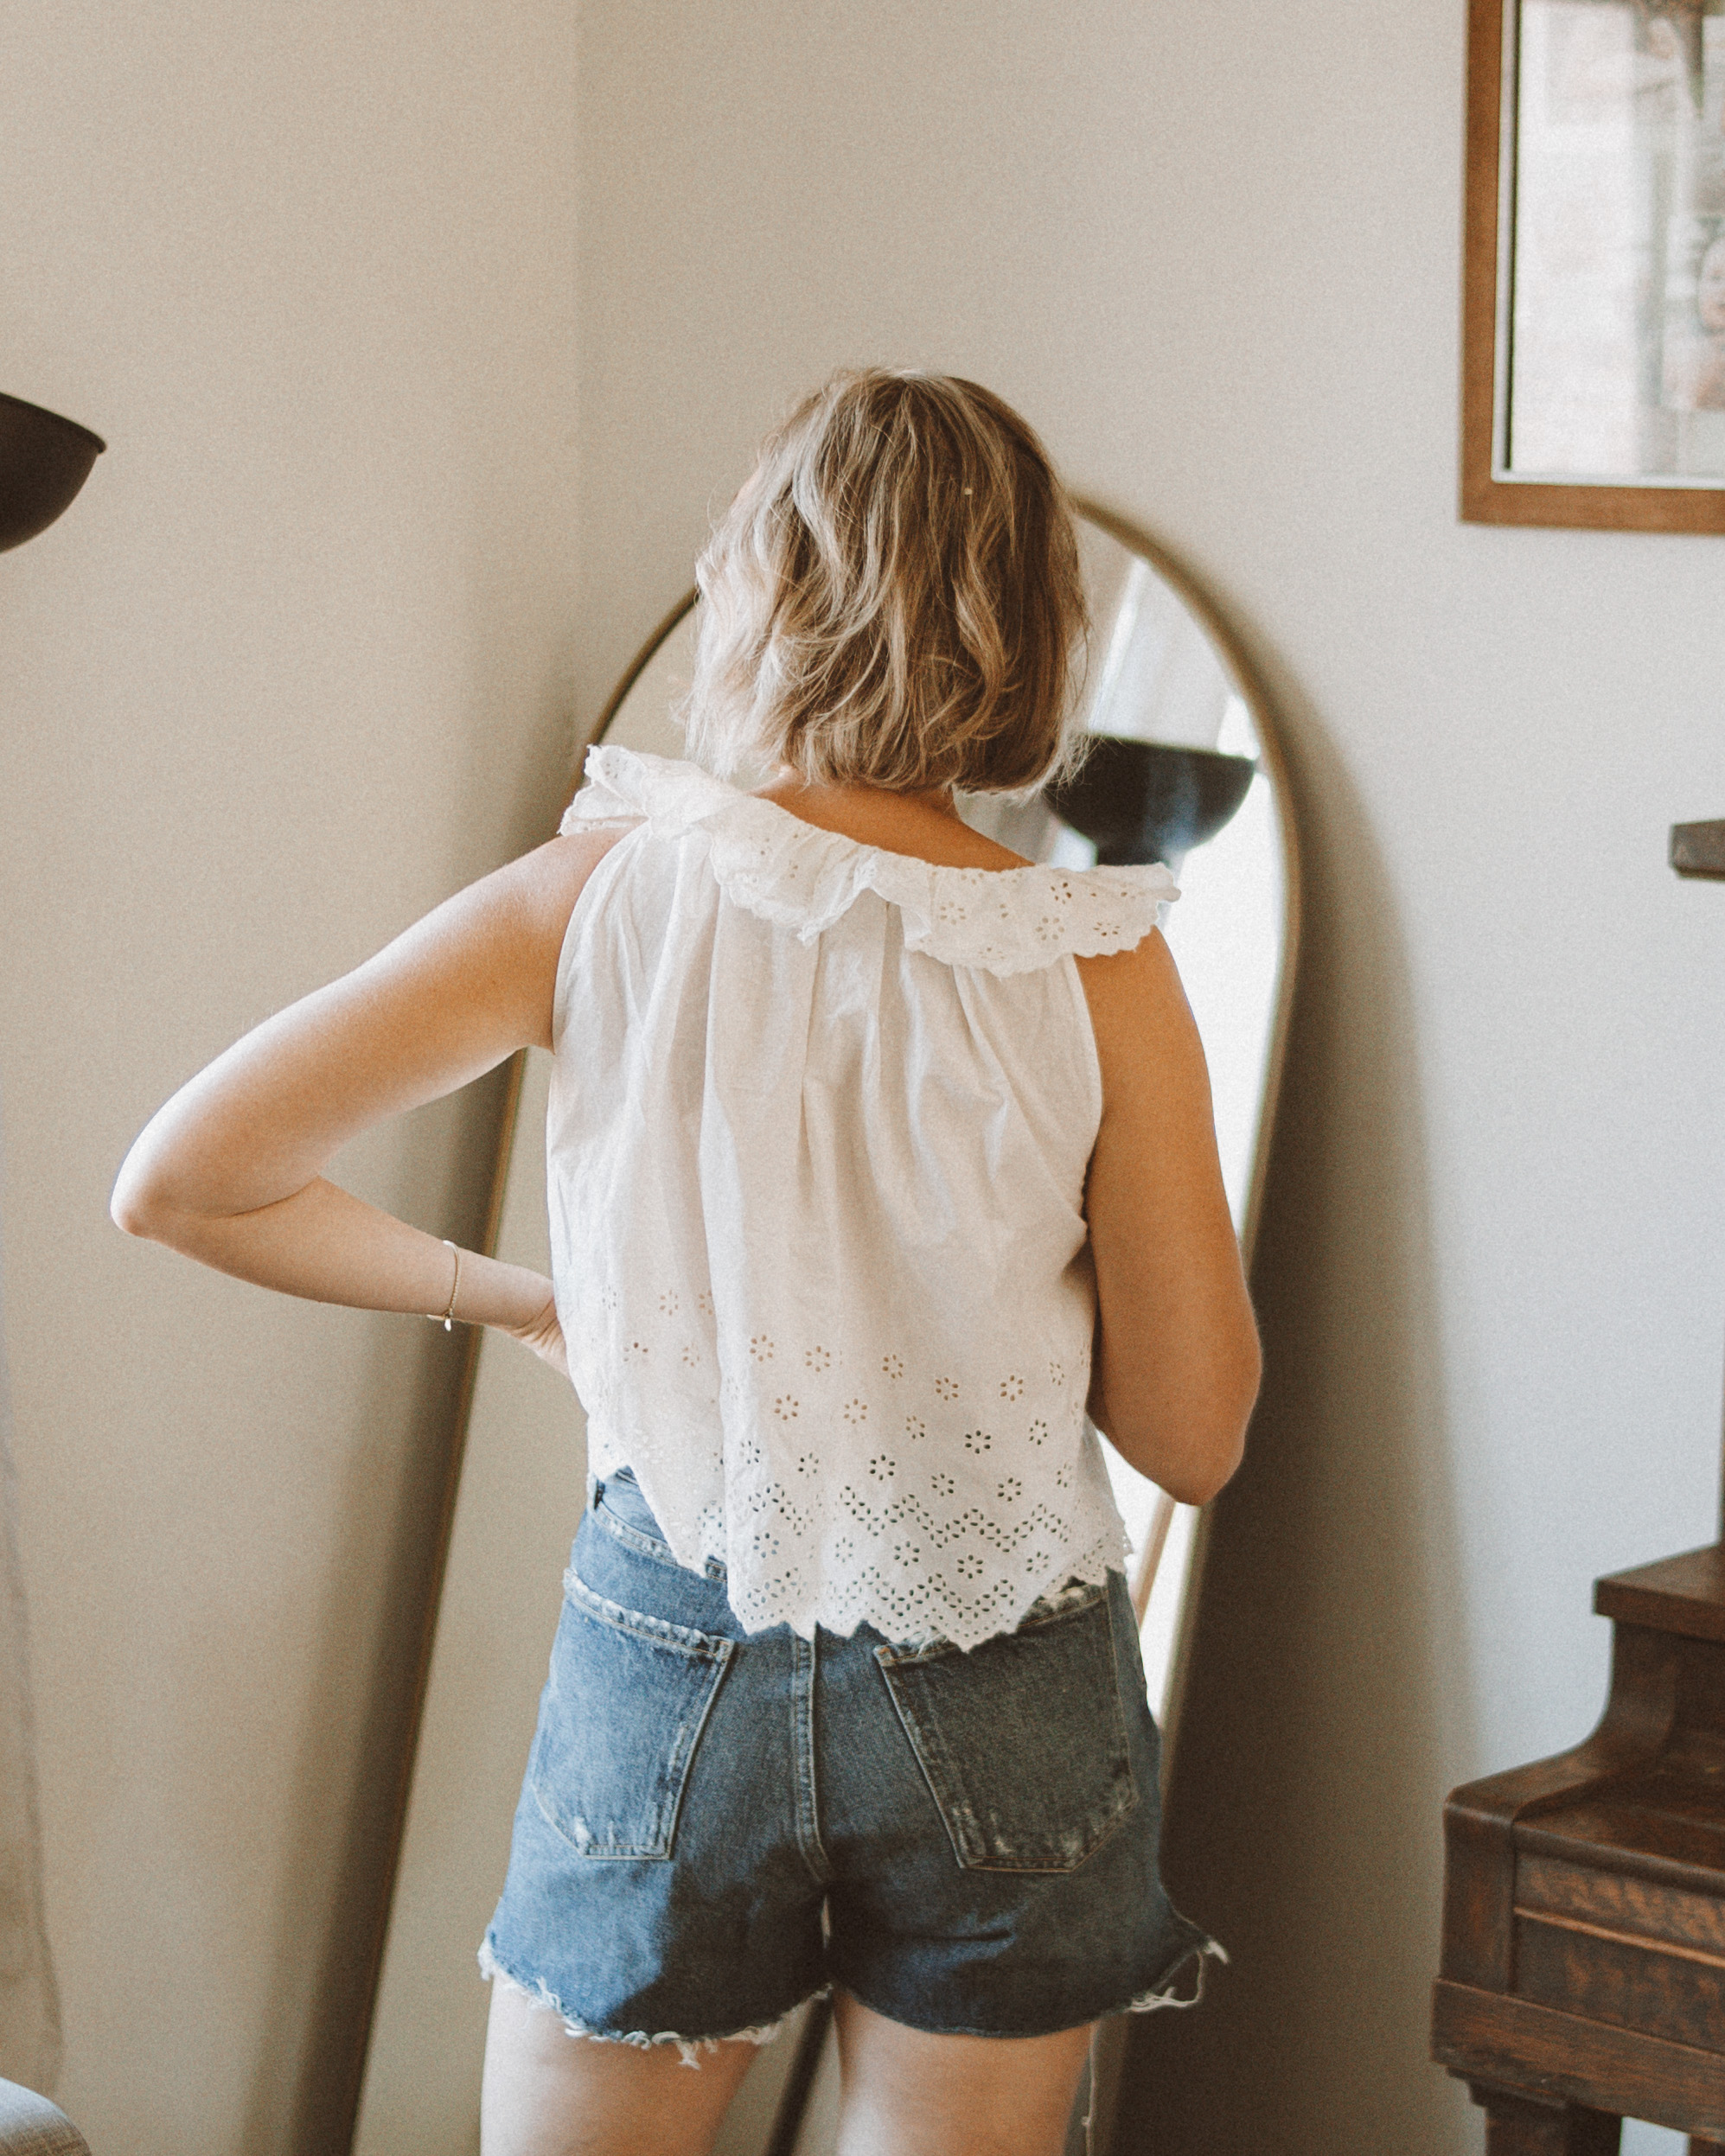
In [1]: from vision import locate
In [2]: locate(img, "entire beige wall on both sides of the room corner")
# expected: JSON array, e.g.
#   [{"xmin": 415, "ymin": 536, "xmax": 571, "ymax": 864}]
[{"xmin": 0, "ymin": 0, "xmax": 1725, "ymax": 2156}]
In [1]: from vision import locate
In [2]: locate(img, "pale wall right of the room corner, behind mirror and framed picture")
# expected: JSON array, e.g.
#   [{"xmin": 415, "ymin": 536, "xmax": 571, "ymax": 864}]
[{"xmin": 578, "ymin": 0, "xmax": 1725, "ymax": 2156}]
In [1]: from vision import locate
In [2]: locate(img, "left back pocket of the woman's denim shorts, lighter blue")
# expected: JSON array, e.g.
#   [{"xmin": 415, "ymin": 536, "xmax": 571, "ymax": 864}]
[{"xmin": 526, "ymin": 1572, "xmax": 735, "ymax": 1856}]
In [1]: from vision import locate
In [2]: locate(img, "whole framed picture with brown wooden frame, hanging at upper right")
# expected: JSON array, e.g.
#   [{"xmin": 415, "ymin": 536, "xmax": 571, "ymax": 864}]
[{"xmin": 1462, "ymin": 0, "xmax": 1725, "ymax": 533}]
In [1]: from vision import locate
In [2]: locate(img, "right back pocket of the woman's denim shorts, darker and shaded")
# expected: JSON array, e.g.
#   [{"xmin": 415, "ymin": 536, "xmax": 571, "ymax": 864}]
[{"xmin": 875, "ymin": 1587, "xmax": 1139, "ymax": 1872}]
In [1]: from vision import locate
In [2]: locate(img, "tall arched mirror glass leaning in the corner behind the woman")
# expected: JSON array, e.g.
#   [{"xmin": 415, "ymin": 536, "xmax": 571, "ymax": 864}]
[{"xmin": 354, "ymin": 509, "xmax": 1298, "ymax": 2156}]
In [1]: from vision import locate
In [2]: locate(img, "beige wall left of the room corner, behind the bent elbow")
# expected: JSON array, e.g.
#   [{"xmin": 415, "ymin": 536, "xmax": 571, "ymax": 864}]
[{"xmin": 0, "ymin": 0, "xmax": 576, "ymax": 2156}]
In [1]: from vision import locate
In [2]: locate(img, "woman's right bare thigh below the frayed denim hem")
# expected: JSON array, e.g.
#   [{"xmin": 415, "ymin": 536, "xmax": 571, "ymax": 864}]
[{"xmin": 833, "ymin": 1990, "xmax": 1091, "ymax": 2156}]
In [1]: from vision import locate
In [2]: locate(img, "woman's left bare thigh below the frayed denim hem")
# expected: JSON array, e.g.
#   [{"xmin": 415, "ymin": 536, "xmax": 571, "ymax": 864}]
[{"xmin": 479, "ymin": 1983, "xmax": 757, "ymax": 2156}]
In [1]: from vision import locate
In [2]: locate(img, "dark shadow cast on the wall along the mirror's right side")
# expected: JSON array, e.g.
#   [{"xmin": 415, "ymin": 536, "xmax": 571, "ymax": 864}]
[{"xmin": 1119, "ymin": 668, "xmax": 1479, "ymax": 2156}]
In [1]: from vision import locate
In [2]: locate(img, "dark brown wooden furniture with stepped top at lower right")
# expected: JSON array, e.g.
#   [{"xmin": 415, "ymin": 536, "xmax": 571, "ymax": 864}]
[{"xmin": 1432, "ymin": 1544, "xmax": 1725, "ymax": 2156}]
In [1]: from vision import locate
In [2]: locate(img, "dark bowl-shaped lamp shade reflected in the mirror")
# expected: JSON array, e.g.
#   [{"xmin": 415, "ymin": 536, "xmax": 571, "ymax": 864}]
[{"xmin": 1045, "ymin": 733, "xmax": 1257, "ymax": 869}]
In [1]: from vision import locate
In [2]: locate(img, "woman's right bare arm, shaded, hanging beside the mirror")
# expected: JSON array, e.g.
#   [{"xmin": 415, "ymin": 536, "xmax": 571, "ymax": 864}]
[{"xmin": 1078, "ymin": 934, "xmax": 1259, "ymax": 1505}]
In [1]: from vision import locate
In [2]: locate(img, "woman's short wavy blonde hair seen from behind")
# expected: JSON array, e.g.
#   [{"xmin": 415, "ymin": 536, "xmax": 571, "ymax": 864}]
[{"xmin": 684, "ymin": 367, "xmax": 1089, "ymax": 794}]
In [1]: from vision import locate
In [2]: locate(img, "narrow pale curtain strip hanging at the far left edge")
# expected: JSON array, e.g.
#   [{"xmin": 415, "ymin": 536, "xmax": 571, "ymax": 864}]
[{"xmin": 0, "ymin": 1086, "xmax": 61, "ymax": 2095}]
